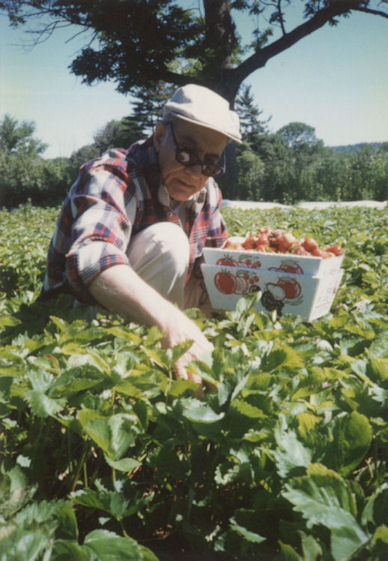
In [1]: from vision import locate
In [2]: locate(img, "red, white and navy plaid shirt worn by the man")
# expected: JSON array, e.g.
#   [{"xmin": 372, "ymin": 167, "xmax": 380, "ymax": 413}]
[{"xmin": 40, "ymin": 137, "xmax": 227, "ymax": 303}]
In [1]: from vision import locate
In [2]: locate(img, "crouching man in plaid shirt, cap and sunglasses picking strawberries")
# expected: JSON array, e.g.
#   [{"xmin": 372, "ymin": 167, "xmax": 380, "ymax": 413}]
[{"xmin": 41, "ymin": 84, "xmax": 241, "ymax": 383}]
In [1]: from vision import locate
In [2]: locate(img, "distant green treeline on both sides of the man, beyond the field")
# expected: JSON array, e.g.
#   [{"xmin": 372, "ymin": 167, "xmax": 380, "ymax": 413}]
[{"xmin": 0, "ymin": 108, "xmax": 388, "ymax": 208}]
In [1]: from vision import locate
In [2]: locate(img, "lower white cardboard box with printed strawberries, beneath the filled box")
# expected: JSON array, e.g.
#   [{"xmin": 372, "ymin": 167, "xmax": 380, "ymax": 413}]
[{"xmin": 201, "ymin": 262, "xmax": 343, "ymax": 321}]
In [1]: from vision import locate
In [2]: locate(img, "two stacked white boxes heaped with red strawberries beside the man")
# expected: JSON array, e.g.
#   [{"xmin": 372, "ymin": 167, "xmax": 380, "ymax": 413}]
[{"xmin": 202, "ymin": 228, "xmax": 343, "ymax": 320}]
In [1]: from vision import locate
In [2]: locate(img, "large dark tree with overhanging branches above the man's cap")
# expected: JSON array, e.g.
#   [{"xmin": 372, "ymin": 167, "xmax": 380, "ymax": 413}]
[{"xmin": 0, "ymin": 0, "xmax": 388, "ymax": 104}]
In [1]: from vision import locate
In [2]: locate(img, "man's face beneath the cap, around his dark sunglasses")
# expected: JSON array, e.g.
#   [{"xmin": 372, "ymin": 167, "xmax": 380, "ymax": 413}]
[{"xmin": 154, "ymin": 119, "xmax": 228, "ymax": 201}]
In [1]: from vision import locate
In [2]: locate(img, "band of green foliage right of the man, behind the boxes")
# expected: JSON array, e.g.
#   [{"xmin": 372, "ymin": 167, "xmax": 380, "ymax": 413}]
[{"xmin": 230, "ymin": 135, "xmax": 388, "ymax": 204}]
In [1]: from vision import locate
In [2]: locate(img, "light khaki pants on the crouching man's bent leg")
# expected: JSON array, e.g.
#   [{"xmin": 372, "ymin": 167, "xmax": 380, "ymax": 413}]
[{"xmin": 127, "ymin": 222, "xmax": 212, "ymax": 315}]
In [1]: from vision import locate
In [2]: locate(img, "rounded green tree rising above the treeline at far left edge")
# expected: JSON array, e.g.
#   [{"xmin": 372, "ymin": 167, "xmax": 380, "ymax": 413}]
[{"xmin": 0, "ymin": 114, "xmax": 47, "ymax": 157}]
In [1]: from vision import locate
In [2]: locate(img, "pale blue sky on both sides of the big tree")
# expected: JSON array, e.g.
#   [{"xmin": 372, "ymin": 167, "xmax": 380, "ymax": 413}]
[{"xmin": 0, "ymin": 2, "xmax": 388, "ymax": 158}]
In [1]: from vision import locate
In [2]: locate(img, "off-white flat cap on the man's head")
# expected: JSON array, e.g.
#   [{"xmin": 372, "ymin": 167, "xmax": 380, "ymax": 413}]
[{"xmin": 163, "ymin": 84, "xmax": 241, "ymax": 142}]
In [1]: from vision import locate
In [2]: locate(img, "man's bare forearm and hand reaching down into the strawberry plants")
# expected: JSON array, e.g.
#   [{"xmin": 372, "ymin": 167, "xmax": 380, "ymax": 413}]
[{"xmin": 89, "ymin": 265, "xmax": 213, "ymax": 384}]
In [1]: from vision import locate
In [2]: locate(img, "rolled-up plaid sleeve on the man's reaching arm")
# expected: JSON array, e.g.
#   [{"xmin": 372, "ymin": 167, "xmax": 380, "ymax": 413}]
[{"xmin": 65, "ymin": 165, "xmax": 132, "ymax": 301}]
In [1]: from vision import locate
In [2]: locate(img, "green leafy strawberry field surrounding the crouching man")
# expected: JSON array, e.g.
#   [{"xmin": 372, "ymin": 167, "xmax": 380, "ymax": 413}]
[{"xmin": 0, "ymin": 207, "xmax": 388, "ymax": 561}]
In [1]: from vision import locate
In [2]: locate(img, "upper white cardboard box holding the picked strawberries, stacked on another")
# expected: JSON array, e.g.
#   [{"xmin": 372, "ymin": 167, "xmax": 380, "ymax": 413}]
[{"xmin": 203, "ymin": 236, "xmax": 344, "ymax": 276}]
